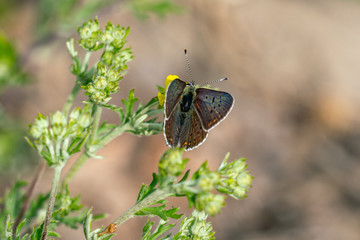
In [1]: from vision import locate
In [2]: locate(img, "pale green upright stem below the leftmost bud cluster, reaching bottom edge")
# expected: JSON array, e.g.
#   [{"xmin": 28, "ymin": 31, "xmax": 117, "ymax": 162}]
[{"xmin": 41, "ymin": 164, "xmax": 64, "ymax": 240}]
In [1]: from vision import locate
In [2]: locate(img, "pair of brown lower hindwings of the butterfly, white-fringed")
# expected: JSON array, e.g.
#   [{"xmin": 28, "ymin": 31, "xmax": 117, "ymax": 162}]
[{"xmin": 164, "ymin": 104, "xmax": 207, "ymax": 151}]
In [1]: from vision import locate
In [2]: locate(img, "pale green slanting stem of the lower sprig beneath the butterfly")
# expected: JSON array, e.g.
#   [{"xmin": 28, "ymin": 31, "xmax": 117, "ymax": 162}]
[{"xmin": 113, "ymin": 189, "xmax": 174, "ymax": 227}]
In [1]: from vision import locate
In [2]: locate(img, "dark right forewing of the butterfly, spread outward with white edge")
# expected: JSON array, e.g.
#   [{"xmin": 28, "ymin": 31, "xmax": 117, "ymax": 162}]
[{"xmin": 194, "ymin": 88, "xmax": 234, "ymax": 131}]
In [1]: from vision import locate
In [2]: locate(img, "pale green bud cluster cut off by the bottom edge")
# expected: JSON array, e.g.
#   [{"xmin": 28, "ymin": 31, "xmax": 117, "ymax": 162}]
[{"xmin": 174, "ymin": 210, "xmax": 215, "ymax": 240}]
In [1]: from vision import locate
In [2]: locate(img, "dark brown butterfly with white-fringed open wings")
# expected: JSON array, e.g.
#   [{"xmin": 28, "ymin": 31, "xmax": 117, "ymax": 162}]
[{"xmin": 164, "ymin": 78, "xmax": 234, "ymax": 151}]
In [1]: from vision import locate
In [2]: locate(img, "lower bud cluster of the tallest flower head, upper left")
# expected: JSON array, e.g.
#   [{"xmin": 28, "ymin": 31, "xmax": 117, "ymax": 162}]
[{"xmin": 82, "ymin": 62, "xmax": 122, "ymax": 104}]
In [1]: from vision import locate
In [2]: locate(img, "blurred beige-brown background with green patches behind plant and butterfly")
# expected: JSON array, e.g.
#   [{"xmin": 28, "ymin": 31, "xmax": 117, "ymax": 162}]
[{"xmin": 0, "ymin": 0, "xmax": 360, "ymax": 240}]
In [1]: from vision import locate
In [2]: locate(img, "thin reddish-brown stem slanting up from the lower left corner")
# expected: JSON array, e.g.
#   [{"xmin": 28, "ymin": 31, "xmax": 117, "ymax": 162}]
[{"xmin": 12, "ymin": 161, "xmax": 46, "ymax": 239}]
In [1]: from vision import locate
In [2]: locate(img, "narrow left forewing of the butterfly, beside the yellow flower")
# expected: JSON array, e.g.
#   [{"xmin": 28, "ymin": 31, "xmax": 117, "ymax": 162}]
[{"xmin": 164, "ymin": 79, "xmax": 186, "ymax": 119}]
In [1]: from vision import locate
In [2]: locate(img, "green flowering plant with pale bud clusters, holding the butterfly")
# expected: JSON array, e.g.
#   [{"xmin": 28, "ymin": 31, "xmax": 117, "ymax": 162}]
[{"xmin": 0, "ymin": 19, "xmax": 252, "ymax": 240}]
